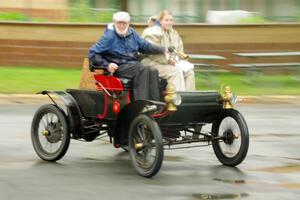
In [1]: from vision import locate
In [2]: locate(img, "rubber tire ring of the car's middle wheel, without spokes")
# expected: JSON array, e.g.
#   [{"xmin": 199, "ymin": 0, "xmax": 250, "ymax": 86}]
[{"xmin": 128, "ymin": 114, "xmax": 164, "ymax": 178}]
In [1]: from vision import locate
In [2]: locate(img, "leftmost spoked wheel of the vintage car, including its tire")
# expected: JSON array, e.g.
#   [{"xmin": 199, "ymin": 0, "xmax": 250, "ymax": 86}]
[{"xmin": 31, "ymin": 104, "xmax": 70, "ymax": 161}]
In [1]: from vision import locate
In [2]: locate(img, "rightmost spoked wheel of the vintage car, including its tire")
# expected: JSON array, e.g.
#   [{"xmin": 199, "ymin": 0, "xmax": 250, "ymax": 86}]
[{"xmin": 212, "ymin": 109, "xmax": 249, "ymax": 166}]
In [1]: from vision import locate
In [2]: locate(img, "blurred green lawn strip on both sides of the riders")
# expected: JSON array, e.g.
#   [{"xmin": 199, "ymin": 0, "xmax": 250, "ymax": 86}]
[{"xmin": 0, "ymin": 66, "xmax": 300, "ymax": 95}]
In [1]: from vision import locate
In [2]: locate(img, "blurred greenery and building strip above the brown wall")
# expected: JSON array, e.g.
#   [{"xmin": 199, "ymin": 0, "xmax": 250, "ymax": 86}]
[{"xmin": 0, "ymin": 0, "xmax": 300, "ymax": 23}]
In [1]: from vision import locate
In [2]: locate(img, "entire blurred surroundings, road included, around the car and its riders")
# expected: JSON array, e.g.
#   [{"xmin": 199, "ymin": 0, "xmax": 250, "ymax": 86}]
[{"xmin": 0, "ymin": 0, "xmax": 300, "ymax": 200}]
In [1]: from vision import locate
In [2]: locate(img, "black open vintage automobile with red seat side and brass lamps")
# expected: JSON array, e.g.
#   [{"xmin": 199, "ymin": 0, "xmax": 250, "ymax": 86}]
[{"xmin": 31, "ymin": 58, "xmax": 249, "ymax": 177}]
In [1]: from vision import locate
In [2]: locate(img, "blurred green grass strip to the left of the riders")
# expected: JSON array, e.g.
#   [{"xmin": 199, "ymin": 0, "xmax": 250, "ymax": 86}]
[{"xmin": 0, "ymin": 66, "xmax": 81, "ymax": 94}]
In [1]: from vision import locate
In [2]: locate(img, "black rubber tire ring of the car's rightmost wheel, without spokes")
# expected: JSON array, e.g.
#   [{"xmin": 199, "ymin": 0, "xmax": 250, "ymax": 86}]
[{"xmin": 212, "ymin": 109, "xmax": 249, "ymax": 166}]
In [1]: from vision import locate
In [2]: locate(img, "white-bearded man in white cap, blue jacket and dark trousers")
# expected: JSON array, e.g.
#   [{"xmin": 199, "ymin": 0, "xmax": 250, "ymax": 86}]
[{"xmin": 89, "ymin": 12, "xmax": 166, "ymax": 100}]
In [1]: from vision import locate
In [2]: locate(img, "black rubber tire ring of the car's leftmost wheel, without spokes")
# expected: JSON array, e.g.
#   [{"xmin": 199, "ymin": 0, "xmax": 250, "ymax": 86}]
[{"xmin": 31, "ymin": 104, "xmax": 70, "ymax": 162}]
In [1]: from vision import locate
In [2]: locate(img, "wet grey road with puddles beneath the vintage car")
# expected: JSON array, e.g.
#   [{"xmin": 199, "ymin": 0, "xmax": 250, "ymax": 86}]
[{"xmin": 0, "ymin": 104, "xmax": 300, "ymax": 200}]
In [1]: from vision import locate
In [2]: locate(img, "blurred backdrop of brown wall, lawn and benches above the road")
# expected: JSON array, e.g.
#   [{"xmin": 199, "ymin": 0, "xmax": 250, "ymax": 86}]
[{"xmin": 0, "ymin": 0, "xmax": 300, "ymax": 95}]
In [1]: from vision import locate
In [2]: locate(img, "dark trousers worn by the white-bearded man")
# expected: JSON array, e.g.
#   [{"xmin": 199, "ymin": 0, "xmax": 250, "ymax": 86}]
[{"xmin": 115, "ymin": 62, "xmax": 160, "ymax": 101}]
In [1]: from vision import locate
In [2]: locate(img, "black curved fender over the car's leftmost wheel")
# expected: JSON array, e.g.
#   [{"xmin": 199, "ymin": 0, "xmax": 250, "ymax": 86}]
[{"xmin": 37, "ymin": 91, "xmax": 82, "ymax": 139}]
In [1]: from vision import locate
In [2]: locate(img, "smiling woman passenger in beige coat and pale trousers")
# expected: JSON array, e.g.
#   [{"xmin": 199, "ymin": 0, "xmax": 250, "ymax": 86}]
[{"xmin": 142, "ymin": 10, "xmax": 195, "ymax": 91}]
